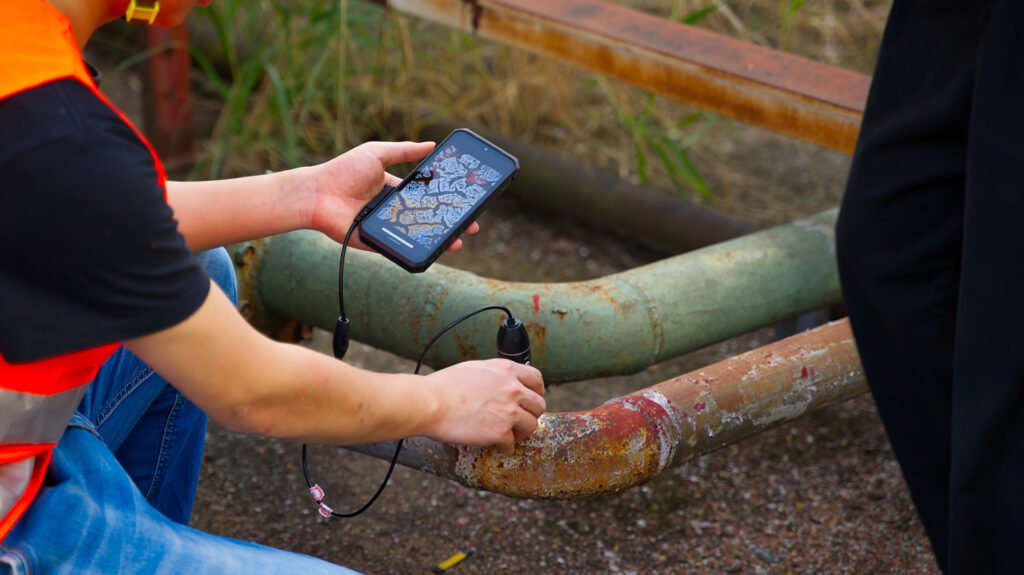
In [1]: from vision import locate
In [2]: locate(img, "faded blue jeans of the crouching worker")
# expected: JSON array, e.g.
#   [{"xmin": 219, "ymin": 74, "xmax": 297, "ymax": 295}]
[{"xmin": 0, "ymin": 249, "xmax": 353, "ymax": 575}]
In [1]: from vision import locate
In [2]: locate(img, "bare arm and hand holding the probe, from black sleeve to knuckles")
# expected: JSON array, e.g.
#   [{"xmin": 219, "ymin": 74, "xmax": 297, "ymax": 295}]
[{"xmin": 125, "ymin": 280, "xmax": 546, "ymax": 453}]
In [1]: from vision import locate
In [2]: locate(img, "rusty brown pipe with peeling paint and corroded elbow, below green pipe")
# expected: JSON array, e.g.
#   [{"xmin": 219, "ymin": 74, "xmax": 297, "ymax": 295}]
[{"xmin": 352, "ymin": 319, "xmax": 867, "ymax": 499}]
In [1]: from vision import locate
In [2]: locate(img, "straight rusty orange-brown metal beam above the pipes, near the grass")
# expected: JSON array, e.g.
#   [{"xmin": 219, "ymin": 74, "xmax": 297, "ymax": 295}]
[{"xmin": 364, "ymin": 0, "xmax": 870, "ymax": 153}]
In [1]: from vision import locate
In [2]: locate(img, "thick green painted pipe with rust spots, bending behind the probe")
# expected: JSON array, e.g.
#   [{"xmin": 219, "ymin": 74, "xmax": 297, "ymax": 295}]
[{"xmin": 242, "ymin": 210, "xmax": 841, "ymax": 383}]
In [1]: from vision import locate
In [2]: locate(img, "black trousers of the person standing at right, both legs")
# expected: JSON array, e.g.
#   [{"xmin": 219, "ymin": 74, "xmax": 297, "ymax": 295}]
[{"xmin": 837, "ymin": 0, "xmax": 1024, "ymax": 574}]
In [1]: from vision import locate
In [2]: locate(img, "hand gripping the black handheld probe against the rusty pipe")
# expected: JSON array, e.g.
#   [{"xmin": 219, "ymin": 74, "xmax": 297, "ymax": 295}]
[{"xmin": 426, "ymin": 359, "xmax": 547, "ymax": 455}]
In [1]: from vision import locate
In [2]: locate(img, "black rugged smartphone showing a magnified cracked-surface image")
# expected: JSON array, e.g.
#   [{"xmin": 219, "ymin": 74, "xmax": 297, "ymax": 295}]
[{"xmin": 359, "ymin": 129, "xmax": 519, "ymax": 273}]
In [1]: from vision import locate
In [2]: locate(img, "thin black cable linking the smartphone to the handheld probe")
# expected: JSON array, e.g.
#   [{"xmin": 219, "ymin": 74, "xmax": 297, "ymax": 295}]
[{"xmin": 302, "ymin": 192, "xmax": 512, "ymax": 518}]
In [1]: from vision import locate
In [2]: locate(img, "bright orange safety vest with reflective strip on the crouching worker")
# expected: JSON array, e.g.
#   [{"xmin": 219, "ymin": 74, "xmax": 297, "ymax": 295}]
[{"xmin": 0, "ymin": 0, "xmax": 167, "ymax": 541}]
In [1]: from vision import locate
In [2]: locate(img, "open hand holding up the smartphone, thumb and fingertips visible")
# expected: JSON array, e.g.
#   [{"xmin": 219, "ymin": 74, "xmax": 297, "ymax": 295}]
[{"xmin": 308, "ymin": 141, "xmax": 480, "ymax": 252}]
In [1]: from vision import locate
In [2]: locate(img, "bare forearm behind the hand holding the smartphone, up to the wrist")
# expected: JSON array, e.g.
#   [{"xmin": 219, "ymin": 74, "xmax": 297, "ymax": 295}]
[{"xmin": 167, "ymin": 168, "xmax": 315, "ymax": 252}]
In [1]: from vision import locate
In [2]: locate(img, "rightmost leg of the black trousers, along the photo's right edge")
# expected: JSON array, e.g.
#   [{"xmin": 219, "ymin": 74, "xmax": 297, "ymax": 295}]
[{"xmin": 949, "ymin": 0, "xmax": 1024, "ymax": 573}]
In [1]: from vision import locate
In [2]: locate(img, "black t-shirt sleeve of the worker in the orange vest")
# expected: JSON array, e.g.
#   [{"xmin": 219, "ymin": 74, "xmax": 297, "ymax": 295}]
[{"xmin": 0, "ymin": 80, "xmax": 210, "ymax": 363}]
